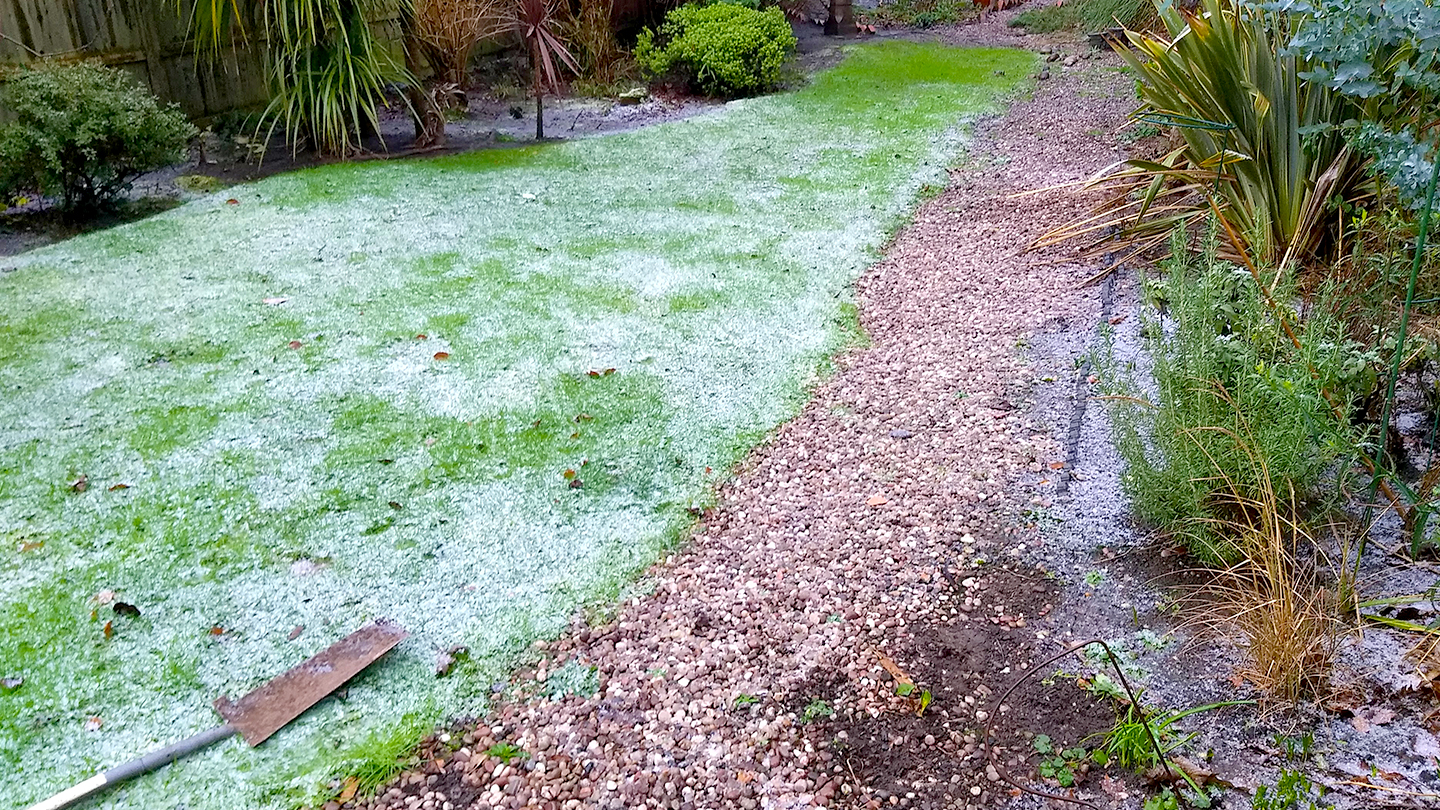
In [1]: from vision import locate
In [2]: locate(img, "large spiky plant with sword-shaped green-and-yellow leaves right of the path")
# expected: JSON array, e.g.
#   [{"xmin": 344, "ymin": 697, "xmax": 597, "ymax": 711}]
[{"xmin": 1120, "ymin": 0, "xmax": 1369, "ymax": 265}]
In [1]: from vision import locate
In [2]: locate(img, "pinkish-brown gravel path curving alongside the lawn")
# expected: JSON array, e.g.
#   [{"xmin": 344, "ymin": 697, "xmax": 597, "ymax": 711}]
[{"xmin": 348, "ymin": 25, "xmax": 1133, "ymax": 810}]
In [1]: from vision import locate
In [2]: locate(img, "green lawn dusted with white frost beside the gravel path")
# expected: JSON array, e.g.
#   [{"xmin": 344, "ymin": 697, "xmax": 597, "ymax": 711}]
[{"xmin": 0, "ymin": 43, "xmax": 1031, "ymax": 810}]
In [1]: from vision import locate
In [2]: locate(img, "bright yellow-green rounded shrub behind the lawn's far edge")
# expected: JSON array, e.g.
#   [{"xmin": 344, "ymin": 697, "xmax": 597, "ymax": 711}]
[{"xmin": 635, "ymin": 3, "xmax": 795, "ymax": 97}]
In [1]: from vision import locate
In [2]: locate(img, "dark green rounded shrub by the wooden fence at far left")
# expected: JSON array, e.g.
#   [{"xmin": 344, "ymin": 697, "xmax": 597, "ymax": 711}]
[{"xmin": 0, "ymin": 63, "xmax": 196, "ymax": 212}]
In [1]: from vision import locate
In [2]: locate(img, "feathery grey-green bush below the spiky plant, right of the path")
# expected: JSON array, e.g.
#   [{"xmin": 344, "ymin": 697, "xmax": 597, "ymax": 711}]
[{"xmin": 1100, "ymin": 229, "xmax": 1374, "ymax": 562}]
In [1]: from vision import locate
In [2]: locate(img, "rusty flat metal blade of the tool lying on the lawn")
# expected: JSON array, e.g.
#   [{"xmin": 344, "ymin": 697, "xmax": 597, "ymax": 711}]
[{"xmin": 215, "ymin": 620, "xmax": 409, "ymax": 747}]
